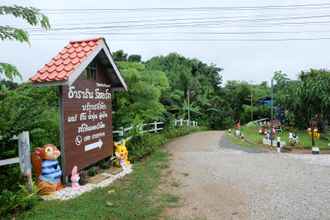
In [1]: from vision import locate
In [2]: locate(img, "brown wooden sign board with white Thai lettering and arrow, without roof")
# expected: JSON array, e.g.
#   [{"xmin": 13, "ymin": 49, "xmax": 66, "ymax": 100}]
[{"xmin": 61, "ymin": 69, "xmax": 113, "ymax": 176}]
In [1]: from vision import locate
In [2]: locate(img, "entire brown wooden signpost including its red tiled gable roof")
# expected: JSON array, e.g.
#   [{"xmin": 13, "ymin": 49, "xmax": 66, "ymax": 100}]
[{"xmin": 30, "ymin": 38, "xmax": 127, "ymax": 182}]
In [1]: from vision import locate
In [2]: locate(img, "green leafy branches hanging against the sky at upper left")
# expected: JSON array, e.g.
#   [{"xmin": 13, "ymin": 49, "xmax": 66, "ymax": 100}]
[{"xmin": 0, "ymin": 5, "xmax": 50, "ymax": 80}]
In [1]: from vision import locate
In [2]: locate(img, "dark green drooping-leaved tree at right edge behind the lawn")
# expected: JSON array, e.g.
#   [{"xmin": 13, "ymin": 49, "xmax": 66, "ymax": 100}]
[{"xmin": 274, "ymin": 69, "xmax": 330, "ymax": 129}]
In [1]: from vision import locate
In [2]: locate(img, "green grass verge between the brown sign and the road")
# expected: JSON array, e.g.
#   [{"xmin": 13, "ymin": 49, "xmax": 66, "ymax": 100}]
[{"xmin": 17, "ymin": 149, "xmax": 178, "ymax": 220}]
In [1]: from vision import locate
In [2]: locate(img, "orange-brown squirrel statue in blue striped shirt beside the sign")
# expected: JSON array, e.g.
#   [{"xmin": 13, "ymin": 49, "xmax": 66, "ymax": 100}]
[{"xmin": 31, "ymin": 144, "xmax": 63, "ymax": 195}]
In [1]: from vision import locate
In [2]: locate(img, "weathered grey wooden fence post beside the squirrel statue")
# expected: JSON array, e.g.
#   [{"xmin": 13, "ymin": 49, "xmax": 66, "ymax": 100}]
[{"xmin": 18, "ymin": 131, "xmax": 32, "ymax": 192}]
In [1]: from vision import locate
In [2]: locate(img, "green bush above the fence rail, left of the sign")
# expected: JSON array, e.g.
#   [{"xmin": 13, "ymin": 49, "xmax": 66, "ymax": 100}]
[{"xmin": 0, "ymin": 84, "xmax": 59, "ymax": 152}]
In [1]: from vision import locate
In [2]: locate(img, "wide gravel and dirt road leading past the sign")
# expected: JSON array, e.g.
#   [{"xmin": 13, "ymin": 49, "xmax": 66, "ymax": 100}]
[{"xmin": 167, "ymin": 131, "xmax": 330, "ymax": 220}]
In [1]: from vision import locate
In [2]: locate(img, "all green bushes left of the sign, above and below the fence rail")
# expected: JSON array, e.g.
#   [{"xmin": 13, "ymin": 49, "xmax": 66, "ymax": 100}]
[{"xmin": 0, "ymin": 82, "xmax": 59, "ymax": 216}]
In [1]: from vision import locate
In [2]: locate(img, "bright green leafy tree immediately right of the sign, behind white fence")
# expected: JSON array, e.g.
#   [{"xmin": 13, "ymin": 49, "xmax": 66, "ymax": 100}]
[{"xmin": 113, "ymin": 62, "xmax": 169, "ymax": 126}]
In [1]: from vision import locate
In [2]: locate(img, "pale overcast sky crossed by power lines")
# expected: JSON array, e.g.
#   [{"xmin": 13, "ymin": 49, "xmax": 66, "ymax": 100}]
[{"xmin": 0, "ymin": 0, "xmax": 330, "ymax": 83}]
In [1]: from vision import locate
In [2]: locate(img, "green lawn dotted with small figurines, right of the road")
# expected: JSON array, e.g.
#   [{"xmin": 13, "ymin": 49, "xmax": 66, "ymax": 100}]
[{"xmin": 237, "ymin": 125, "xmax": 330, "ymax": 150}]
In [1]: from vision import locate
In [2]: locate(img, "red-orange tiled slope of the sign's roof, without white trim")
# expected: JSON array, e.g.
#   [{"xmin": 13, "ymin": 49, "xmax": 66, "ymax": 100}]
[{"xmin": 31, "ymin": 38, "xmax": 103, "ymax": 83}]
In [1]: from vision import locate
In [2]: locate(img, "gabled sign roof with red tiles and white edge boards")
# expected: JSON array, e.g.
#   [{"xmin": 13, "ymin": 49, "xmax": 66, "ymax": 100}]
[{"xmin": 30, "ymin": 37, "xmax": 127, "ymax": 90}]
